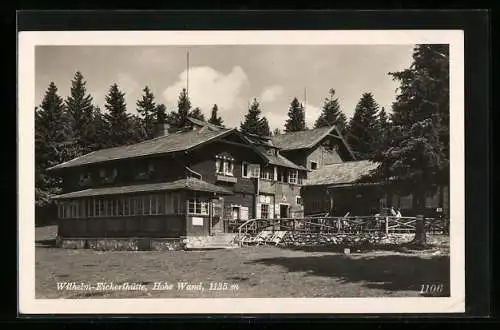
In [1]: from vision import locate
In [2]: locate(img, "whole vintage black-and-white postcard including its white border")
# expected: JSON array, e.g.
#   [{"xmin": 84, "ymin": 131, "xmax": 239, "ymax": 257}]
[{"xmin": 18, "ymin": 30, "xmax": 465, "ymax": 314}]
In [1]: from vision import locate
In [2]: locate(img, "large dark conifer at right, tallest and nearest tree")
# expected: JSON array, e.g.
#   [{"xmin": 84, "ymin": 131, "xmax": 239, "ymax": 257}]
[{"xmin": 374, "ymin": 44, "xmax": 450, "ymax": 244}]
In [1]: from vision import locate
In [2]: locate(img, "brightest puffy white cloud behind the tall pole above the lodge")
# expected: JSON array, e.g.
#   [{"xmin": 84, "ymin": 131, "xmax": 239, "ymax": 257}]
[{"xmin": 163, "ymin": 66, "xmax": 248, "ymax": 127}]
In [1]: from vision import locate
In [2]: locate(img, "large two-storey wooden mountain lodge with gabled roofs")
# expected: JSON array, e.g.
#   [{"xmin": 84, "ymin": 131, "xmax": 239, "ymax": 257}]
[{"xmin": 49, "ymin": 119, "xmax": 450, "ymax": 249}]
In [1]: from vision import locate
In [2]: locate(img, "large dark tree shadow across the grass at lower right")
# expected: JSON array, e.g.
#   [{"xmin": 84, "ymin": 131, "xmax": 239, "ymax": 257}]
[{"xmin": 247, "ymin": 251, "xmax": 450, "ymax": 296}]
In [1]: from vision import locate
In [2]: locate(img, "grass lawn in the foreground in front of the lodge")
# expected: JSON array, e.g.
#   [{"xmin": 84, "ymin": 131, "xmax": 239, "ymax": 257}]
[{"xmin": 35, "ymin": 224, "xmax": 449, "ymax": 299}]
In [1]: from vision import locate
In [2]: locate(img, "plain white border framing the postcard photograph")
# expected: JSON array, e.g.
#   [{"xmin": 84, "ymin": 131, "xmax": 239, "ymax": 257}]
[{"xmin": 17, "ymin": 30, "xmax": 465, "ymax": 314}]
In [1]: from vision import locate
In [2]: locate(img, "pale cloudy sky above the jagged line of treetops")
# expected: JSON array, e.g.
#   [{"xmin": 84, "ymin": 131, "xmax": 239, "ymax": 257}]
[{"xmin": 35, "ymin": 45, "xmax": 413, "ymax": 129}]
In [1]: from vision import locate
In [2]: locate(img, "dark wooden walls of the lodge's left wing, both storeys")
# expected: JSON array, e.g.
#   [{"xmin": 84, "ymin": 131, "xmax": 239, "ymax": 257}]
[{"xmin": 52, "ymin": 129, "xmax": 306, "ymax": 238}]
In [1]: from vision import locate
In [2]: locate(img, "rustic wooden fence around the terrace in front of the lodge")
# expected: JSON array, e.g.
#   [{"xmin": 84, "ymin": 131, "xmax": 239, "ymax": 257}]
[{"xmin": 234, "ymin": 216, "xmax": 448, "ymax": 235}]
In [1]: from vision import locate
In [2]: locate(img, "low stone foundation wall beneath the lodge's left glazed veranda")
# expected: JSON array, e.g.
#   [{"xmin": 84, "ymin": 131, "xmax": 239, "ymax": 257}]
[{"xmin": 56, "ymin": 237, "xmax": 185, "ymax": 251}]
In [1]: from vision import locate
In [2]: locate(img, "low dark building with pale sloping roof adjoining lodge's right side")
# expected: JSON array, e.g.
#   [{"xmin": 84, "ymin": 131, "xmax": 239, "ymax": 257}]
[{"xmin": 302, "ymin": 160, "xmax": 449, "ymax": 217}]
